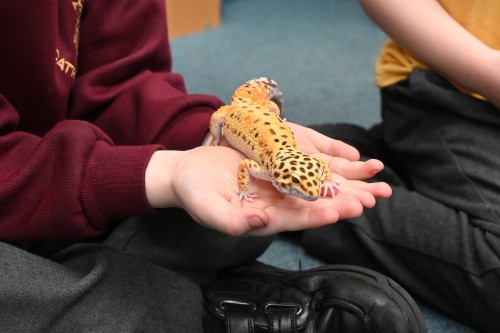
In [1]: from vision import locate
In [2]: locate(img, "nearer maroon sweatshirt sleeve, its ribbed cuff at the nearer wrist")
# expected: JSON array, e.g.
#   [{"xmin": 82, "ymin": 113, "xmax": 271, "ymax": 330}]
[{"xmin": 0, "ymin": 94, "xmax": 161, "ymax": 241}]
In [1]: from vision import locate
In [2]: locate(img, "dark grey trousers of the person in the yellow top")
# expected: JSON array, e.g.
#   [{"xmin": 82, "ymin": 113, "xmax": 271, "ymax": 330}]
[{"xmin": 302, "ymin": 70, "xmax": 500, "ymax": 332}]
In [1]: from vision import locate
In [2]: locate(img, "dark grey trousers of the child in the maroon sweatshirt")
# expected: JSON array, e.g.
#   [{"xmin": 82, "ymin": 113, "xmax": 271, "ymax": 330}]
[{"xmin": 0, "ymin": 209, "xmax": 272, "ymax": 333}]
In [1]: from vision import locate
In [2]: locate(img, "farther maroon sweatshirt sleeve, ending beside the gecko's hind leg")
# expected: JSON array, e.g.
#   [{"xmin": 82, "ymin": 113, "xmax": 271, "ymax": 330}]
[{"xmin": 72, "ymin": 0, "xmax": 222, "ymax": 149}]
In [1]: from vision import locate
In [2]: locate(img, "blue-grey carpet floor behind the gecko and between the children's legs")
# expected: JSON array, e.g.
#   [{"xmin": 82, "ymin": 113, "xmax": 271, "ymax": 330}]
[{"xmin": 172, "ymin": 0, "xmax": 480, "ymax": 333}]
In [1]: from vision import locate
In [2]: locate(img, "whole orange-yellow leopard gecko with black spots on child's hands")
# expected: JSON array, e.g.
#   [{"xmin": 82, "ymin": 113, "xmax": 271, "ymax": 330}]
[{"xmin": 210, "ymin": 77, "xmax": 340, "ymax": 201}]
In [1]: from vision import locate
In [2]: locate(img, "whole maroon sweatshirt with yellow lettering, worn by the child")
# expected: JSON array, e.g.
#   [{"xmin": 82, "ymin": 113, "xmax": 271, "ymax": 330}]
[{"xmin": 0, "ymin": 0, "xmax": 221, "ymax": 241}]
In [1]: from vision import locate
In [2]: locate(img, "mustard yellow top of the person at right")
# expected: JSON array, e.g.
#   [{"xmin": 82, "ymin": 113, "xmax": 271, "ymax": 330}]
[{"xmin": 375, "ymin": 0, "xmax": 500, "ymax": 97}]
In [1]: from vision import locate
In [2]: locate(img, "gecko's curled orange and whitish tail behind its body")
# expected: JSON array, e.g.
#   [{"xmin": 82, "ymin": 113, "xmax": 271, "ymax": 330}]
[{"xmin": 233, "ymin": 77, "xmax": 283, "ymax": 112}]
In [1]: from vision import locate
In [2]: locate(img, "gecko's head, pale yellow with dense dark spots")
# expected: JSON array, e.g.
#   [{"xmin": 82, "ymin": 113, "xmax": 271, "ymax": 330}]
[{"xmin": 272, "ymin": 148, "xmax": 324, "ymax": 201}]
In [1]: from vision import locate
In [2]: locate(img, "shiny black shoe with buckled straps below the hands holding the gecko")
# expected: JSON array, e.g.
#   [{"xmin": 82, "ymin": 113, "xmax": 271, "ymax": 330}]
[{"xmin": 203, "ymin": 263, "xmax": 427, "ymax": 333}]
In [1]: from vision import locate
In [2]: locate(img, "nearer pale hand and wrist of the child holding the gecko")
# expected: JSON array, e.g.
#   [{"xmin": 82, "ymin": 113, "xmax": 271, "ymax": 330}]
[{"xmin": 146, "ymin": 137, "xmax": 391, "ymax": 236}]
